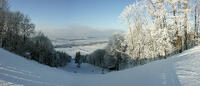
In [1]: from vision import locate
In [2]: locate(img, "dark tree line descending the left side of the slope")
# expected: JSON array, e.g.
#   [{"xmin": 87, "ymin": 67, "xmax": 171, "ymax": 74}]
[{"xmin": 0, "ymin": 0, "xmax": 71, "ymax": 67}]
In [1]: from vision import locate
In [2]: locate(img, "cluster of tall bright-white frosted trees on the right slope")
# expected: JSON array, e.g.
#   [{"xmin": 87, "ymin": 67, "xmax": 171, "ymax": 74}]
[{"xmin": 120, "ymin": 0, "xmax": 195, "ymax": 62}]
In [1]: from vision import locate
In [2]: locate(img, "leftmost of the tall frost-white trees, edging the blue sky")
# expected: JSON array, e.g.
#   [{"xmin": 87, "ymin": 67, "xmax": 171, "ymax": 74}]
[{"xmin": 120, "ymin": 1, "xmax": 147, "ymax": 59}]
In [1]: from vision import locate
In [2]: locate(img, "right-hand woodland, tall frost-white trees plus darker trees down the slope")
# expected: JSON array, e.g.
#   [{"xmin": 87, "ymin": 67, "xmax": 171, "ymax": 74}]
[{"xmin": 74, "ymin": 0, "xmax": 200, "ymax": 70}]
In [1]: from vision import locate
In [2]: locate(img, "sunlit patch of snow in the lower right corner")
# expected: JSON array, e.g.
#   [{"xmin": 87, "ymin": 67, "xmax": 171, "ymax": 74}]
[{"xmin": 175, "ymin": 48, "xmax": 200, "ymax": 86}]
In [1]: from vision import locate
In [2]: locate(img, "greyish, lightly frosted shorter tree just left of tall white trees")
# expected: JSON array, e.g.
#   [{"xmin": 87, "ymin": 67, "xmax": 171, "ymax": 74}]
[{"xmin": 104, "ymin": 33, "xmax": 127, "ymax": 70}]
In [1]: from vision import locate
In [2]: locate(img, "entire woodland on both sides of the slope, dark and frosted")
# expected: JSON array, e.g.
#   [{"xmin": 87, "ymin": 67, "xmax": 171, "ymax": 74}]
[{"xmin": 0, "ymin": 0, "xmax": 200, "ymax": 70}]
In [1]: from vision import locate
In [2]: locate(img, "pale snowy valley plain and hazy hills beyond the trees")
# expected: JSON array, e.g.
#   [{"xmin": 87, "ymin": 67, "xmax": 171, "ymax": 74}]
[{"xmin": 41, "ymin": 25, "xmax": 123, "ymax": 58}]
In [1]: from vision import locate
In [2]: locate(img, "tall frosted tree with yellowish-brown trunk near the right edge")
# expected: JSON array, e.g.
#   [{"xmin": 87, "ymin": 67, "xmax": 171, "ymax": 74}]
[{"xmin": 168, "ymin": 0, "xmax": 192, "ymax": 52}]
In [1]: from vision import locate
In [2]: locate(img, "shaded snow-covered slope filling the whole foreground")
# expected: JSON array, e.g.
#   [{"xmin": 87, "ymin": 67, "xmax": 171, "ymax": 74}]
[{"xmin": 0, "ymin": 46, "xmax": 200, "ymax": 86}]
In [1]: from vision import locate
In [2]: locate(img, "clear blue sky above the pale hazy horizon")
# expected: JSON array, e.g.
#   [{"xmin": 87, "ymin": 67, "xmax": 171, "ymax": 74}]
[{"xmin": 9, "ymin": 0, "xmax": 134, "ymax": 29}]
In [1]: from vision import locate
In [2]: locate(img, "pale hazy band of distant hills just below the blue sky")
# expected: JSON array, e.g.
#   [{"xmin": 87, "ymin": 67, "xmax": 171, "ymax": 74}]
[{"xmin": 38, "ymin": 26, "xmax": 123, "ymax": 40}]
